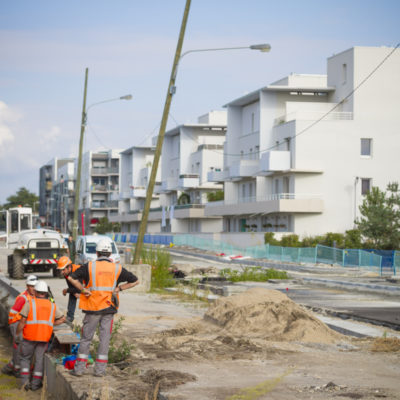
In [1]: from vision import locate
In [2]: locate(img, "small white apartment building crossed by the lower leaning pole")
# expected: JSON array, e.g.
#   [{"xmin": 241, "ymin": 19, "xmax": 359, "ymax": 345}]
[{"xmin": 110, "ymin": 146, "xmax": 161, "ymax": 233}]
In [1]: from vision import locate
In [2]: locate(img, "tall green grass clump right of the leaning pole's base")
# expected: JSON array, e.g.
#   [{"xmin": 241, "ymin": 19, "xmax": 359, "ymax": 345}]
[{"xmin": 141, "ymin": 246, "xmax": 175, "ymax": 291}]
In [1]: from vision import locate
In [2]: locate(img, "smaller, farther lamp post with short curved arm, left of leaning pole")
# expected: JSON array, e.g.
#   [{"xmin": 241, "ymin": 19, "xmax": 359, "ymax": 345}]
[{"xmin": 72, "ymin": 68, "xmax": 132, "ymax": 241}]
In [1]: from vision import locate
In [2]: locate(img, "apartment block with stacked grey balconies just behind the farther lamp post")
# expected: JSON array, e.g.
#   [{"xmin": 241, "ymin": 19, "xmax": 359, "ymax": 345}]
[{"xmin": 76, "ymin": 150, "xmax": 121, "ymax": 234}]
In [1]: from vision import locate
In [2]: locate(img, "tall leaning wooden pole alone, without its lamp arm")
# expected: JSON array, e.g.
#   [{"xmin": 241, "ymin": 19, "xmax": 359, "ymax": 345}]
[{"xmin": 133, "ymin": 0, "xmax": 191, "ymax": 264}]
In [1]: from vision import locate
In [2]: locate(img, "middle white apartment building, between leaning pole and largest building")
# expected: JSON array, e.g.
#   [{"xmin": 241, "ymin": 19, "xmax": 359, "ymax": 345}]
[{"xmin": 153, "ymin": 111, "xmax": 226, "ymax": 233}]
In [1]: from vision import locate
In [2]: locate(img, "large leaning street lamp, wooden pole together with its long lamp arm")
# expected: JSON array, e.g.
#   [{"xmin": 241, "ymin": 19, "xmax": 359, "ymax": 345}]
[{"xmin": 133, "ymin": 36, "xmax": 271, "ymax": 264}]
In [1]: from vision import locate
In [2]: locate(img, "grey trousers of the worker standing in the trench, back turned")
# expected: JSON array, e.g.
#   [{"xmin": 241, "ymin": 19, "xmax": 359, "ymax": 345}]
[{"xmin": 20, "ymin": 339, "xmax": 49, "ymax": 389}]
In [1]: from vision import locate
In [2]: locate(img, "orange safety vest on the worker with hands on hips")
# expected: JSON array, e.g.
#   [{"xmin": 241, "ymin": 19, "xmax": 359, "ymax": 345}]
[{"xmin": 79, "ymin": 261, "xmax": 122, "ymax": 311}]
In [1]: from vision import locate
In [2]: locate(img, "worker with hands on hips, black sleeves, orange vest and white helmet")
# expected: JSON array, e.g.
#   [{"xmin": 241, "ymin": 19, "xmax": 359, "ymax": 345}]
[{"xmin": 68, "ymin": 239, "xmax": 139, "ymax": 376}]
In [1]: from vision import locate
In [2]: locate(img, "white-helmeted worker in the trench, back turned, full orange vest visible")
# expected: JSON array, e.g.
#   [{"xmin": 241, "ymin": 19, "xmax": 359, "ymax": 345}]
[{"xmin": 17, "ymin": 281, "xmax": 65, "ymax": 391}]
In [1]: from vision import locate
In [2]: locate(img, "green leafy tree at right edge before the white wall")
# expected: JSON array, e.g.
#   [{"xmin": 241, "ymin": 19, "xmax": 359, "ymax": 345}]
[{"xmin": 355, "ymin": 183, "xmax": 400, "ymax": 249}]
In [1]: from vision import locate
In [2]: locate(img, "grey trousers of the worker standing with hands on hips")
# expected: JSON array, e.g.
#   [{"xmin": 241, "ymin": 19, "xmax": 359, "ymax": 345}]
[{"xmin": 74, "ymin": 313, "xmax": 114, "ymax": 375}]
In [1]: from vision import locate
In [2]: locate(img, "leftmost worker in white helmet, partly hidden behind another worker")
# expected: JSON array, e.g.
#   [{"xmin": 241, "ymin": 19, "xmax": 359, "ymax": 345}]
[{"xmin": 1, "ymin": 275, "xmax": 38, "ymax": 377}]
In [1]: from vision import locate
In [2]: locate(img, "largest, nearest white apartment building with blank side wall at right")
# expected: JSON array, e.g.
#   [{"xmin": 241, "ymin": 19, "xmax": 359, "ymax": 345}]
[{"xmin": 205, "ymin": 47, "xmax": 400, "ymax": 237}]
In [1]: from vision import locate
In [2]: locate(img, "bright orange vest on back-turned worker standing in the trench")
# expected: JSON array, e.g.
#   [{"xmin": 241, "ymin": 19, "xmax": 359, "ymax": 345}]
[{"xmin": 23, "ymin": 297, "xmax": 56, "ymax": 342}]
